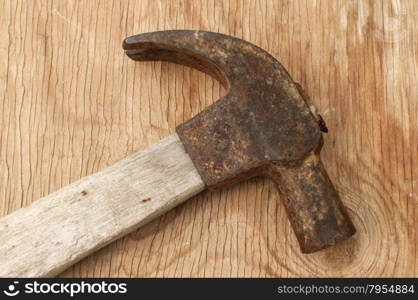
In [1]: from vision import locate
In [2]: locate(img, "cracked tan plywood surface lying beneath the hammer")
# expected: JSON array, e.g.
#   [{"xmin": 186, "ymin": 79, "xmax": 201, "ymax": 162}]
[{"xmin": 0, "ymin": 0, "xmax": 418, "ymax": 277}]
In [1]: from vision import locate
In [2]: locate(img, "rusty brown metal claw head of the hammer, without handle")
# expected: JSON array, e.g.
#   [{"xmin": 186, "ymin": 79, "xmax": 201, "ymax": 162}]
[{"xmin": 123, "ymin": 30, "xmax": 355, "ymax": 253}]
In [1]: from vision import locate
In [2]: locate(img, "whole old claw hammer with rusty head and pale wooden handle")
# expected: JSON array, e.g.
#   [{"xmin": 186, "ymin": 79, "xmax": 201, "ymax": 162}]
[{"xmin": 0, "ymin": 30, "xmax": 355, "ymax": 277}]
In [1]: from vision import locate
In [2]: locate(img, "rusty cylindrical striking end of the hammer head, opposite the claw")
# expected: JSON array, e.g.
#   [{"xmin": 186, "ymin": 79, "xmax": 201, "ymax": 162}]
[{"xmin": 268, "ymin": 154, "xmax": 356, "ymax": 253}]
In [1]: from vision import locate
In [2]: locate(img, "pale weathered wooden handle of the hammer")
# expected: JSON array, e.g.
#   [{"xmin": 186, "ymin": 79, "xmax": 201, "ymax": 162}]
[{"xmin": 0, "ymin": 134, "xmax": 204, "ymax": 277}]
